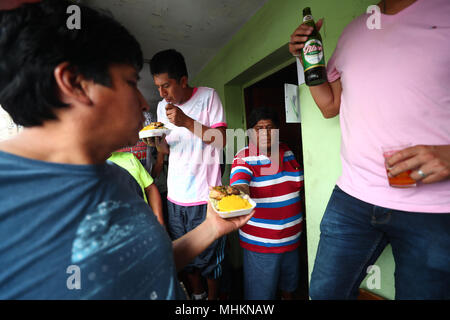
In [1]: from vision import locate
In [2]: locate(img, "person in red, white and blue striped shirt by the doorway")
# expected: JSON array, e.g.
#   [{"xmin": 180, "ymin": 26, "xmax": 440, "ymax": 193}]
[{"xmin": 230, "ymin": 107, "xmax": 303, "ymax": 300}]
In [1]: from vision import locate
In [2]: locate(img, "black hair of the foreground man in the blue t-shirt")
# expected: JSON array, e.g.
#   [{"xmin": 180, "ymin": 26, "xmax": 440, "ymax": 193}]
[{"xmin": 0, "ymin": 0, "xmax": 143, "ymax": 127}]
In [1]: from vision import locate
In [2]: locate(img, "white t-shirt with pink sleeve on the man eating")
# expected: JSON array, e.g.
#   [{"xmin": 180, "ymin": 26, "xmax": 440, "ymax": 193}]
[{"xmin": 157, "ymin": 87, "xmax": 227, "ymax": 206}]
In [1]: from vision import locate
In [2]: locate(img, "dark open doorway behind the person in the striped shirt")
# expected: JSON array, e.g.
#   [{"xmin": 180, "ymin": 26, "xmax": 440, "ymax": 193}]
[{"xmin": 244, "ymin": 62, "xmax": 309, "ymax": 299}]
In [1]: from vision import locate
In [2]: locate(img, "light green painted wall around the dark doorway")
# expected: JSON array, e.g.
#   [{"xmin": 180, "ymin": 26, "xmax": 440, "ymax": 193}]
[{"xmin": 191, "ymin": 0, "xmax": 395, "ymax": 299}]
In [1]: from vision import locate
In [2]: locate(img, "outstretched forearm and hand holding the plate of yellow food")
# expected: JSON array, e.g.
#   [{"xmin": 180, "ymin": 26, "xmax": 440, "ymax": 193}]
[{"xmin": 172, "ymin": 203, "xmax": 254, "ymax": 271}]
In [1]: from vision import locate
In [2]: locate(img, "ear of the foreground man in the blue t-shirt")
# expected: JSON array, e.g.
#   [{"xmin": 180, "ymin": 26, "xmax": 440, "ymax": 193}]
[{"xmin": 53, "ymin": 62, "xmax": 93, "ymax": 105}]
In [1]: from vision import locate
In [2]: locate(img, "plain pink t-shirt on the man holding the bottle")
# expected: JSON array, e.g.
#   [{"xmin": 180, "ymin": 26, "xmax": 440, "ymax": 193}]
[{"xmin": 328, "ymin": 0, "xmax": 450, "ymax": 213}]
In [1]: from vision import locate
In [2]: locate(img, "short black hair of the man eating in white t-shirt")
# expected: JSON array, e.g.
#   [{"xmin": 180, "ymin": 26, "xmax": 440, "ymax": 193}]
[{"xmin": 150, "ymin": 49, "xmax": 188, "ymax": 82}]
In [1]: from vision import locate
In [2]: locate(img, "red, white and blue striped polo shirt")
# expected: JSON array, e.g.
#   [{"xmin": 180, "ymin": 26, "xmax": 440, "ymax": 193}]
[{"xmin": 230, "ymin": 143, "xmax": 303, "ymax": 253}]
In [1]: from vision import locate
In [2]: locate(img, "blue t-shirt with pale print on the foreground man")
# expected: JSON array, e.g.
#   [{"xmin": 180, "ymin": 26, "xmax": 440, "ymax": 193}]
[{"xmin": 0, "ymin": 152, "xmax": 186, "ymax": 299}]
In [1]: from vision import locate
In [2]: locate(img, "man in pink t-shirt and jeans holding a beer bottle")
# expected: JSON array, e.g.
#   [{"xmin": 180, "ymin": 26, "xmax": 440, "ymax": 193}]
[{"xmin": 290, "ymin": 0, "xmax": 450, "ymax": 299}]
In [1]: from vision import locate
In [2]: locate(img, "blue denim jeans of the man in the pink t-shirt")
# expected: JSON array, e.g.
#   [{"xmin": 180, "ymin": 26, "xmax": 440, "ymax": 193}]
[{"xmin": 310, "ymin": 186, "xmax": 450, "ymax": 299}]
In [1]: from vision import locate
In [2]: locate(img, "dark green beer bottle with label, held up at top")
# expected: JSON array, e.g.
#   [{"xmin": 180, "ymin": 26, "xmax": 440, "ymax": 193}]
[{"xmin": 301, "ymin": 7, "xmax": 327, "ymax": 86}]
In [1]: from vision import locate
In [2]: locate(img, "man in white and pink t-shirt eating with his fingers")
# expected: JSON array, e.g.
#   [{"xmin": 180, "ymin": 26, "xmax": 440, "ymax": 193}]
[{"xmin": 150, "ymin": 49, "xmax": 226, "ymax": 300}]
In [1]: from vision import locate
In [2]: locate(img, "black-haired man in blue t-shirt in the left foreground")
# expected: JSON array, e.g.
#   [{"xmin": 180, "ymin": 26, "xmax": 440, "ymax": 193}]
[{"xmin": 0, "ymin": 0, "xmax": 251, "ymax": 299}]
